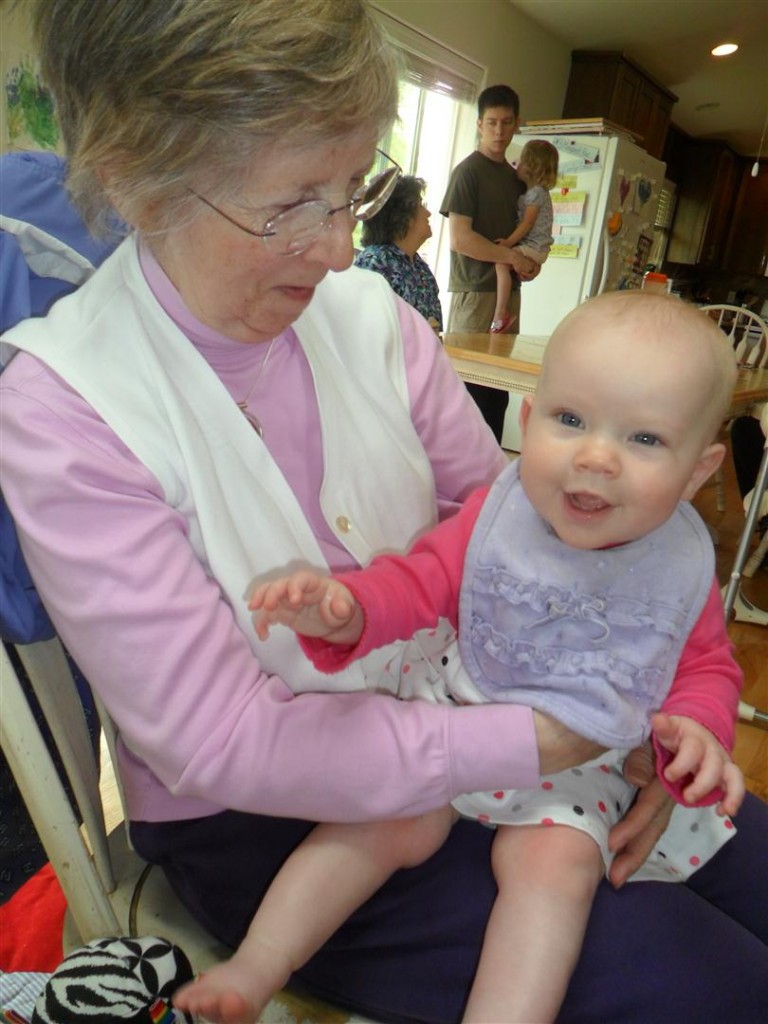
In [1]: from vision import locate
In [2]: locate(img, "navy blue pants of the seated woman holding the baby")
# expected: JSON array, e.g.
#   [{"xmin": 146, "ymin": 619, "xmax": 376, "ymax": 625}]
[{"xmin": 132, "ymin": 797, "xmax": 768, "ymax": 1024}]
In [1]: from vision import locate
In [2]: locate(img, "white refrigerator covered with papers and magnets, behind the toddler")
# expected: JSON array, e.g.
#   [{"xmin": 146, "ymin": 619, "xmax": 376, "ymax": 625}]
[{"xmin": 503, "ymin": 131, "xmax": 666, "ymax": 451}]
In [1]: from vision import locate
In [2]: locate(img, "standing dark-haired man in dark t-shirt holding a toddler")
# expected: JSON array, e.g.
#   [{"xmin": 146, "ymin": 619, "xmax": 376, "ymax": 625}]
[{"xmin": 440, "ymin": 85, "xmax": 539, "ymax": 441}]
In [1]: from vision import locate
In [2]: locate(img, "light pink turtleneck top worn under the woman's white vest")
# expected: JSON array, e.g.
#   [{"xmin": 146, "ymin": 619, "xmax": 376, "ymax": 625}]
[{"xmin": 0, "ymin": 245, "xmax": 538, "ymax": 821}]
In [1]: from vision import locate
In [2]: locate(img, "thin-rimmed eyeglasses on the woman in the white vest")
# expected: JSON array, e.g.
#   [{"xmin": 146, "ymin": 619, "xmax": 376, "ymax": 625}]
[{"xmin": 189, "ymin": 150, "xmax": 402, "ymax": 256}]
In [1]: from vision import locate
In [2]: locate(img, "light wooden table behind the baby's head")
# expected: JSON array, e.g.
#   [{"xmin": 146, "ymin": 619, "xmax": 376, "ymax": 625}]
[{"xmin": 442, "ymin": 334, "xmax": 768, "ymax": 420}]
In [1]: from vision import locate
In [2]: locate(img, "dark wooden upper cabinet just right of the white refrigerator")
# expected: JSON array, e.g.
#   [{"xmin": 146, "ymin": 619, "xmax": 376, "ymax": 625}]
[{"xmin": 666, "ymin": 138, "xmax": 741, "ymax": 267}]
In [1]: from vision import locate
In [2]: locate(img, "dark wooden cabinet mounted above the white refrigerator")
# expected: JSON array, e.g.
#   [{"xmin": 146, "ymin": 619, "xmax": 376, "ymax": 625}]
[{"xmin": 562, "ymin": 50, "xmax": 677, "ymax": 158}]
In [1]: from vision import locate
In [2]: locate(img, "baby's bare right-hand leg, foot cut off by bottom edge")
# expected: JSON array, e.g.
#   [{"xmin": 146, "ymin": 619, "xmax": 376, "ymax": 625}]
[{"xmin": 464, "ymin": 825, "xmax": 603, "ymax": 1024}]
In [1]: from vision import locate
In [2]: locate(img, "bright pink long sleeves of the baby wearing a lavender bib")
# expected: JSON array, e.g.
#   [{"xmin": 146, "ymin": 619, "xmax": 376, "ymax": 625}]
[{"xmin": 301, "ymin": 487, "xmax": 741, "ymax": 804}]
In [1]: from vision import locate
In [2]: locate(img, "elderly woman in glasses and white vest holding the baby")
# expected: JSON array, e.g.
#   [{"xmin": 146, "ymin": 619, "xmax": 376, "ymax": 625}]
[{"xmin": 0, "ymin": 0, "xmax": 768, "ymax": 1024}]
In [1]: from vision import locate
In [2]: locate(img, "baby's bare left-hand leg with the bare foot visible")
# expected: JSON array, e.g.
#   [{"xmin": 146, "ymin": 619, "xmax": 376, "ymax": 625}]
[{"xmin": 173, "ymin": 807, "xmax": 455, "ymax": 1024}]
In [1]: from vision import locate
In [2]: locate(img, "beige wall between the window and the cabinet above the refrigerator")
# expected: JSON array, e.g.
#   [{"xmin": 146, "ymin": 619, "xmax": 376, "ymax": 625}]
[{"xmin": 375, "ymin": 0, "xmax": 570, "ymax": 121}]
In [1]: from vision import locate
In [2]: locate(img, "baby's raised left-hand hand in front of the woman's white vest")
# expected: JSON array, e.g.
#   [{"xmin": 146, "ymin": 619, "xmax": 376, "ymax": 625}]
[{"xmin": 248, "ymin": 569, "xmax": 364, "ymax": 644}]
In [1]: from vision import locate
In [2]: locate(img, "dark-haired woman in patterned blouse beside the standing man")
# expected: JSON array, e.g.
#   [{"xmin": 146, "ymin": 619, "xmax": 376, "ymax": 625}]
[{"xmin": 354, "ymin": 174, "xmax": 442, "ymax": 331}]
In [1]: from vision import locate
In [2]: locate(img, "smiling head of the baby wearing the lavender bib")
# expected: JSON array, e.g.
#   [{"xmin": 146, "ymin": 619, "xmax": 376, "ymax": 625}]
[{"xmin": 521, "ymin": 317, "xmax": 722, "ymax": 549}]
